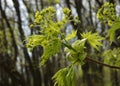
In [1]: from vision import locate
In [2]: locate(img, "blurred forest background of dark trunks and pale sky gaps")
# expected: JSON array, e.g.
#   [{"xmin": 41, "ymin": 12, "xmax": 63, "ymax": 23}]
[{"xmin": 0, "ymin": 0, "xmax": 120, "ymax": 86}]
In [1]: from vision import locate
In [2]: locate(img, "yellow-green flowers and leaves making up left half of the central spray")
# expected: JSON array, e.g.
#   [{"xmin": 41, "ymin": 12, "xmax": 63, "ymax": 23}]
[{"xmin": 26, "ymin": 7, "xmax": 77, "ymax": 65}]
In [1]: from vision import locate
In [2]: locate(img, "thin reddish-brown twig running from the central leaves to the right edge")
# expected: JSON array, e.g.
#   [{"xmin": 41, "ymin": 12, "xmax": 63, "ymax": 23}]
[{"xmin": 85, "ymin": 57, "xmax": 120, "ymax": 69}]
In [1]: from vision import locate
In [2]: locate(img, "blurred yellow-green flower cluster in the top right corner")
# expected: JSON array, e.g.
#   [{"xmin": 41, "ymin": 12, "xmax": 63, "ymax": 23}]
[{"xmin": 97, "ymin": 2, "xmax": 117, "ymax": 26}]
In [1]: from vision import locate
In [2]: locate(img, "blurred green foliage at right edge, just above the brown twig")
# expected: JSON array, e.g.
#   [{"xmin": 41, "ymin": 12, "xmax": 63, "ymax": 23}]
[{"xmin": 103, "ymin": 48, "xmax": 120, "ymax": 66}]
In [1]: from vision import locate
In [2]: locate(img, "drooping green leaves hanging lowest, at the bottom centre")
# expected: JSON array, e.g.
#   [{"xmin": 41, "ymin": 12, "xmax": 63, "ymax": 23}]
[{"xmin": 52, "ymin": 66, "xmax": 76, "ymax": 86}]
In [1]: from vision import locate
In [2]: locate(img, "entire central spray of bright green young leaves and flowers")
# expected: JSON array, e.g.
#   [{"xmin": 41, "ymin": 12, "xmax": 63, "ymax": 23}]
[{"xmin": 26, "ymin": 7, "xmax": 103, "ymax": 86}]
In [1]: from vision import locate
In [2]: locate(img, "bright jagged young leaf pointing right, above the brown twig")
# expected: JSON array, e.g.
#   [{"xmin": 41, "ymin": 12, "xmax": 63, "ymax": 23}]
[{"xmin": 81, "ymin": 32, "xmax": 104, "ymax": 50}]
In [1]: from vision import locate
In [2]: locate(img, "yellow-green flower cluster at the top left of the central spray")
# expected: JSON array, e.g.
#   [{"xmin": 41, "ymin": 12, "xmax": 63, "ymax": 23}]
[{"xmin": 32, "ymin": 7, "xmax": 55, "ymax": 29}]
